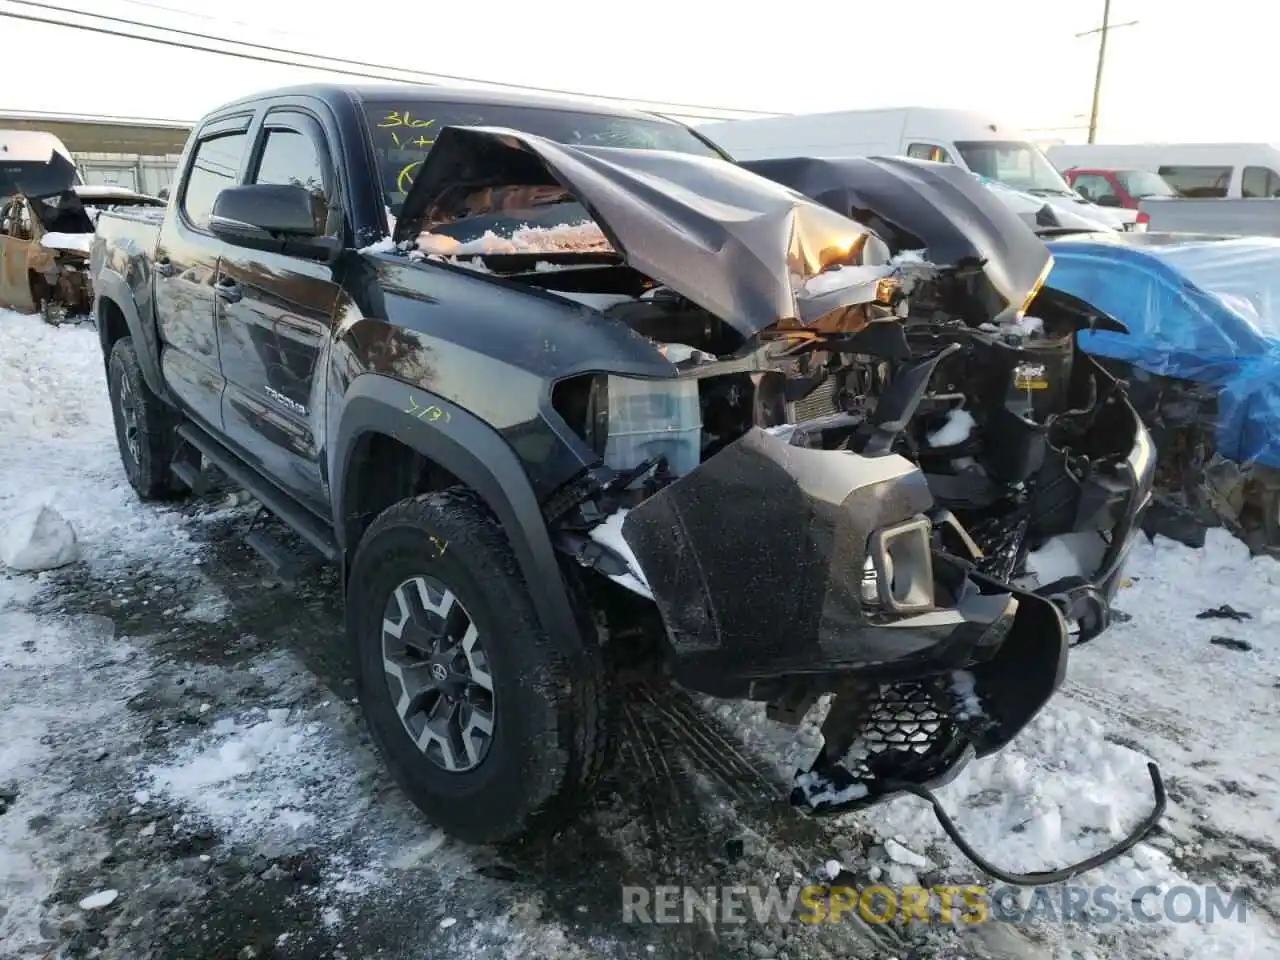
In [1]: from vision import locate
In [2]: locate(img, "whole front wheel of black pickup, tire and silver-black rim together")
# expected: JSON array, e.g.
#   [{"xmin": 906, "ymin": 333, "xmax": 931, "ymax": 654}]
[{"xmin": 347, "ymin": 489, "xmax": 611, "ymax": 844}]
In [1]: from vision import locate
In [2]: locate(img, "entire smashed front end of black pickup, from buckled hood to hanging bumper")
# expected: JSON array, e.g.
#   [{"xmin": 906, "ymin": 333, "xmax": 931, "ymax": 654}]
[{"xmin": 396, "ymin": 128, "xmax": 1162, "ymax": 876}]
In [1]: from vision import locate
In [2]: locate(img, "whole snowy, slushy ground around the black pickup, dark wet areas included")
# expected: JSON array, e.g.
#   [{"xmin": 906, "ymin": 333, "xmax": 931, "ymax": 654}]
[{"xmin": 0, "ymin": 311, "xmax": 1280, "ymax": 960}]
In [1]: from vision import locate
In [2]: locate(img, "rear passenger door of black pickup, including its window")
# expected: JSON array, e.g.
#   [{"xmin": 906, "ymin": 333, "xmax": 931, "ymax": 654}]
[{"xmin": 152, "ymin": 115, "xmax": 252, "ymax": 430}]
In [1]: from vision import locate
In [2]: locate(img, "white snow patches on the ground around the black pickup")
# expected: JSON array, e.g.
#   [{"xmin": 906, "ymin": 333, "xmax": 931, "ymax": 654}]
[{"xmin": 0, "ymin": 311, "xmax": 1280, "ymax": 960}]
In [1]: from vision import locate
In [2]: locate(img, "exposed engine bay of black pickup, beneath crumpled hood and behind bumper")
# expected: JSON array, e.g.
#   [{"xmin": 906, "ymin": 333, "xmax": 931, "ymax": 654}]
[{"xmin": 401, "ymin": 148, "xmax": 1144, "ymax": 640}]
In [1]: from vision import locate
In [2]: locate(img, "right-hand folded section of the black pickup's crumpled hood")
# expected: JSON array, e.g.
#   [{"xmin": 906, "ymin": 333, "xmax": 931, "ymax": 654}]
[{"xmin": 742, "ymin": 156, "xmax": 1053, "ymax": 323}]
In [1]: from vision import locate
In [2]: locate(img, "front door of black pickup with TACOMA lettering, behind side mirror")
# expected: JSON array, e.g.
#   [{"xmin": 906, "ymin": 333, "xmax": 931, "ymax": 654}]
[{"xmin": 215, "ymin": 106, "xmax": 343, "ymax": 515}]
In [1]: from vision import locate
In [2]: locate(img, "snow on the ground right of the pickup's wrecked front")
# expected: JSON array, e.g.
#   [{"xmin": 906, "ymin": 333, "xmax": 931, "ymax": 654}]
[{"xmin": 721, "ymin": 531, "xmax": 1280, "ymax": 960}]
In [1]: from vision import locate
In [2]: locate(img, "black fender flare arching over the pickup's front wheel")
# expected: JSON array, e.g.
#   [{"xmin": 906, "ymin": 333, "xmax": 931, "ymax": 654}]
[{"xmin": 329, "ymin": 374, "xmax": 584, "ymax": 655}]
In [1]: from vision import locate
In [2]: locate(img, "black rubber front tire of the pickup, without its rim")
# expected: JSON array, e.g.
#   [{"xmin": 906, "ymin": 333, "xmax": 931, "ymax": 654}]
[{"xmin": 347, "ymin": 488, "xmax": 616, "ymax": 844}]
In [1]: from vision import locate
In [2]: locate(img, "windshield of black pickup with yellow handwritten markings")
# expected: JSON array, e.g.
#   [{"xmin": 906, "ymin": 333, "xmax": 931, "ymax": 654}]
[{"xmin": 365, "ymin": 100, "xmax": 721, "ymax": 215}]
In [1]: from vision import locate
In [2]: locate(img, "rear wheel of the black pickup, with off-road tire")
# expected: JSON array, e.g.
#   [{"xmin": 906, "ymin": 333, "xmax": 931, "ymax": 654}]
[{"xmin": 106, "ymin": 337, "xmax": 187, "ymax": 500}]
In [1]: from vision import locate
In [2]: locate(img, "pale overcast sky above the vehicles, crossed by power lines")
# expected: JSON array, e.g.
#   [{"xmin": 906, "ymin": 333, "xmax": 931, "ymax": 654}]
[{"xmin": 0, "ymin": 0, "xmax": 1280, "ymax": 142}]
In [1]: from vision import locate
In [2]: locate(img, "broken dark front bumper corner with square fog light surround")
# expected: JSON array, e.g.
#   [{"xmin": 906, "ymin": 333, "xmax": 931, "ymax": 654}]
[{"xmin": 622, "ymin": 430, "xmax": 1065, "ymax": 709}]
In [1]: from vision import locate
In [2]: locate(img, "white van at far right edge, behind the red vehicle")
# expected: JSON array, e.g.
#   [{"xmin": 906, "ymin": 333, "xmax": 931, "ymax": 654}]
[{"xmin": 1048, "ymin": 143, "xmax": 1280, "ymax": 198}]
